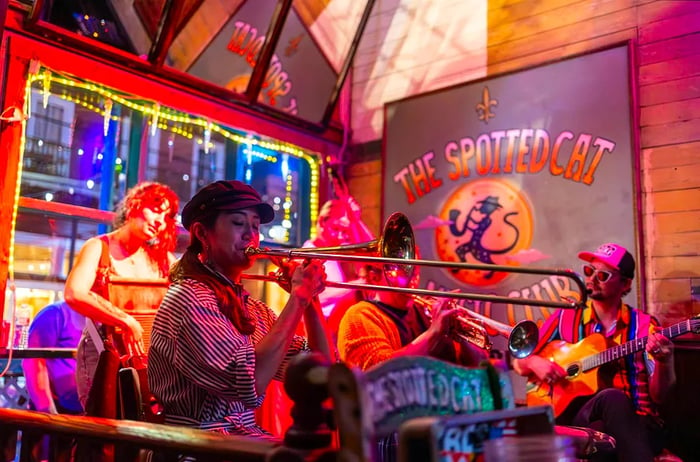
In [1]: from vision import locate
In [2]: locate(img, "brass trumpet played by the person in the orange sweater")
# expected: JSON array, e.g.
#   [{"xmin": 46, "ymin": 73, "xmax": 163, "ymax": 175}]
[{"xmin": 411, "ymin": 295, "xmax": 539, "ymax": 359}]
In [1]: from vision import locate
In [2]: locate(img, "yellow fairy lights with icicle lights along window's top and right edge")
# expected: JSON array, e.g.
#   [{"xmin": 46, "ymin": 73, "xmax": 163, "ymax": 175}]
[{"xmin": 25, "ymin": 68, "xmax": 320, "ymax": 242}]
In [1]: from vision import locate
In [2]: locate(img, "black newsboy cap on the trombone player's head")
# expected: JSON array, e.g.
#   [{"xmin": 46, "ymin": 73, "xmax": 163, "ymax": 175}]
[{"xmin": 182, "ymin": 180, "xmax": 275, "ymax": 231}]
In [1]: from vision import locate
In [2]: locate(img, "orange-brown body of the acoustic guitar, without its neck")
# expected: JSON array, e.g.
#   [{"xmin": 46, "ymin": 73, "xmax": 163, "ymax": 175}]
[{"xmin": 526, "ymin": 334, "xmax": 607, "ymax": 417}]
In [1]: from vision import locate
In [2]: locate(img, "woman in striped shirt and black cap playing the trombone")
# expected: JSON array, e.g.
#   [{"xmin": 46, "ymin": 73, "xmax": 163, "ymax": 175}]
[{"xmin": 148, "ymin": 181, "xmax": 330, "ymax": 438}]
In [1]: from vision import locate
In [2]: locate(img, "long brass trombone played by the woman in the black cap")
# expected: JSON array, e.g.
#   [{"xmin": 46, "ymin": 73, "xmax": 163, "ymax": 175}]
[{"xmin": 243, "ymin": 212, "xmax": 588, "ymax": 309}]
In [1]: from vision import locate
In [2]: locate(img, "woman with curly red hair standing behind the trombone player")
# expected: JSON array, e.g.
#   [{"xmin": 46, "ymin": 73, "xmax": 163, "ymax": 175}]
[{"xmin": 65, "ymin": 182, "xmax": 179, "ymax": 410}]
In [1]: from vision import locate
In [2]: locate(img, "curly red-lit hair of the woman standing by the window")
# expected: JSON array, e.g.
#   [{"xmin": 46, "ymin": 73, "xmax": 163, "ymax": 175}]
[{"xmin": 114, "ymin": 181, "xmax": 180, "ymax": 276}]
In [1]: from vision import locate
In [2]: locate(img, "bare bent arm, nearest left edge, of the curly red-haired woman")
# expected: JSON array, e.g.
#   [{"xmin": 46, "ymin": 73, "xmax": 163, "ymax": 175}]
[{"xmin": 65, "ymin": 238, "xmax": 143, "ymax": 350}]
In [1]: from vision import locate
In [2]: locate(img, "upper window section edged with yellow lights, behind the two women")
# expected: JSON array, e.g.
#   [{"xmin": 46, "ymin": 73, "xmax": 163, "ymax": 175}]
[{"xmin": 20, "ymin": 71, "xmax": 318, "ymax": 247}]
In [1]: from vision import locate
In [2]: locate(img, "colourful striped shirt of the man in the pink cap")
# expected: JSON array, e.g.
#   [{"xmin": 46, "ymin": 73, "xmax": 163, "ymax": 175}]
[{"xmin": 535, "ymin": 301, "xmax": 659, "ymax": 415}]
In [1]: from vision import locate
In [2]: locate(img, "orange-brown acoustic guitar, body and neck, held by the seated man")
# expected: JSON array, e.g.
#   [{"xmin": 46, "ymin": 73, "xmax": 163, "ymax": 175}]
[{"xmin": 526, "ymin": 316, "xmax": 700, "ymax": 417}]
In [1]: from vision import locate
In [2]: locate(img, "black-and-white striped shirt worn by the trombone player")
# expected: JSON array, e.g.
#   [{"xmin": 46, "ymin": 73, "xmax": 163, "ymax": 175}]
[{"xmin": 148, "ymin": 279, "xmax": 308, "ymax": 438}]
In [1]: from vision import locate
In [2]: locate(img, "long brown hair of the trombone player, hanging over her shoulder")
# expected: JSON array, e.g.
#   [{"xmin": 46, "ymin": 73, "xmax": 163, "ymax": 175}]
[{"xmin": 170, "ymin": 211, "xmax": 255, "ymax": 335}]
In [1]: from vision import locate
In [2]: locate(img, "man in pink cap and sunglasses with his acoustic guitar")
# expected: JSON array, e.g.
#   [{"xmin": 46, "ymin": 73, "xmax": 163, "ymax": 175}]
[{"xmin": 513, "ymin": 243, "xmax": 680, "ymax": 462}]
